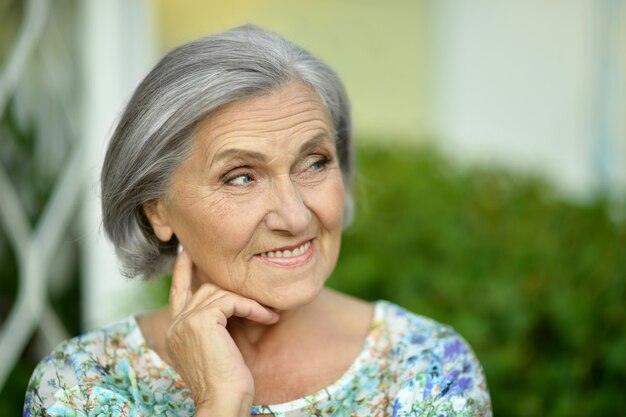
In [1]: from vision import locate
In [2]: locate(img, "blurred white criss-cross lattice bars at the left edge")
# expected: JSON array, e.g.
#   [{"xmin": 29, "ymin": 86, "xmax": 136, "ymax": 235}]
[{"xmin": 0, "ymin": 0, "xmax": 72, "ymax": 387}]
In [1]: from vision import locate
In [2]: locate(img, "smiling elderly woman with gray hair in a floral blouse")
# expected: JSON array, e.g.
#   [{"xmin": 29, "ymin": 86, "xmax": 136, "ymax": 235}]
[{"xmin": 25, "ymin": 26, "xmax": 491, "ymax": 417}]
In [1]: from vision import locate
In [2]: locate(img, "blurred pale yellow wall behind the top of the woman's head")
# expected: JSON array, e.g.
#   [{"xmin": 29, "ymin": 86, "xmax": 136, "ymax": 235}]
[{"xmin": 157, "ymin": 0, "xmax": 432, "ymax": 140}]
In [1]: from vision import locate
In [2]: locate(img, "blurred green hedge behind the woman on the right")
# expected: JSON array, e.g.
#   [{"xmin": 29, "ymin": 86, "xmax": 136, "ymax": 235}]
[{"xmin": 329, "ymin": 142, "xmax": 626, "ymax": 416}]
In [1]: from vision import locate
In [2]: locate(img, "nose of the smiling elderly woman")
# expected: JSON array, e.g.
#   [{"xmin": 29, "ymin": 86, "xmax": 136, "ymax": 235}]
[{"xmin": 265, "ymin": 175, "xmax": 311, "ymax": 235}]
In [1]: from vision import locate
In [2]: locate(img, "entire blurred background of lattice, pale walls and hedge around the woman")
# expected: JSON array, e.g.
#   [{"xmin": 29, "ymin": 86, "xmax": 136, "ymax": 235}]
[{"xmin": 0, "ymin": 0, "xmax": 626, "ymax": 416}]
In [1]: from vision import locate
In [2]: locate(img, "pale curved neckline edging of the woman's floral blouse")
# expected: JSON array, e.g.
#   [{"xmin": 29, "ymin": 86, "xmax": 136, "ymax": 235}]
[{"xmin": 129, "ymin": 301, "xmax": 386, "ymax": 415}]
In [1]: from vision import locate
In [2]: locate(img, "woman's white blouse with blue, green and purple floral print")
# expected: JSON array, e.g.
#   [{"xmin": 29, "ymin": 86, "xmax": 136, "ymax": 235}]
[{"xmin": 24, "ymin": 301, "xmax": 492, "ymax": 417}]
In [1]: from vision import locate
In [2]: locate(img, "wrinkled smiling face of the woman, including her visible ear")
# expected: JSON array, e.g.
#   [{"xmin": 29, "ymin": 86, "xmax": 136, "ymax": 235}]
[{"xmin": 146, "ymin": 82, "xmax": 344, "ymax": 310}]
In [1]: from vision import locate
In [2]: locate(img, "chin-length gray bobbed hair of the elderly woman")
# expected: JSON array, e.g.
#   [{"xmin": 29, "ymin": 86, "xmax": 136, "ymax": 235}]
[{"xmin": 101, "ymin": 25, "xmax": 354, "ymax": 278}]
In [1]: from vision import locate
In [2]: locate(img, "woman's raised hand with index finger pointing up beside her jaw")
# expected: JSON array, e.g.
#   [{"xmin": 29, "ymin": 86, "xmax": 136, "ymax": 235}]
[{"xmin": 166, "ymin": 245, "xmax": 278, "ymax": 417}]
